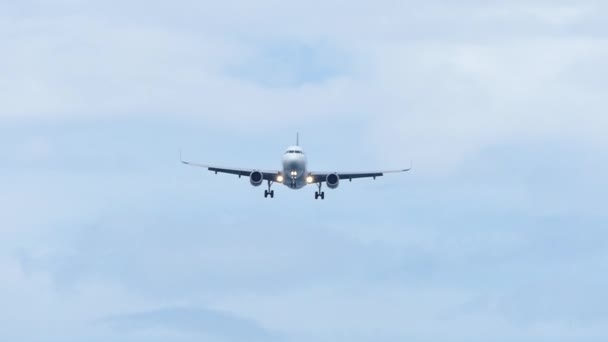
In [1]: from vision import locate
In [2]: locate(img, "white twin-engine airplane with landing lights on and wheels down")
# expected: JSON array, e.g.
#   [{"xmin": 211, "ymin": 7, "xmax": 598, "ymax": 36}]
[{"xmin": 180, "ymin": 134, "xmax": 412, "ymax": 200}]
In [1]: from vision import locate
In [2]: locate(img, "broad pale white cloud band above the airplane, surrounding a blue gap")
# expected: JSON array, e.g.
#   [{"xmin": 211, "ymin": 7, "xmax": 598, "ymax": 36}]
[{"xmin": 0, "ymin": 1, "xmax": 608, "ymax": 171}]
